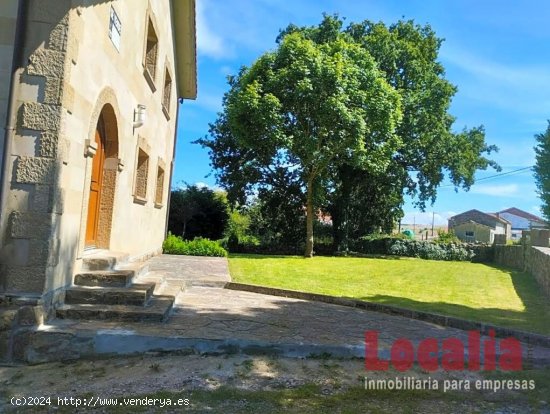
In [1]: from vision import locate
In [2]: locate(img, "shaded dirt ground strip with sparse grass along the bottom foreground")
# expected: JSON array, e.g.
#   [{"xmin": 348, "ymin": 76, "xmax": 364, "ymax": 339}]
[{"xmin": 0, "ymin": 353, "xmax": 550, "ymax": 414}]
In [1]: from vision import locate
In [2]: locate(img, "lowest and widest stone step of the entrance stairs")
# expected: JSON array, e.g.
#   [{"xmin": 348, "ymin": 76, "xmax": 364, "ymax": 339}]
[{"xmin": 56, "ymin": 297, "xmax": 174, "ymax": 322}]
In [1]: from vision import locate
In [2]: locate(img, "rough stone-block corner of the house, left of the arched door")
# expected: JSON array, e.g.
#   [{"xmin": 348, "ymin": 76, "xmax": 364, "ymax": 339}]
[{"xmin": 1, "ymin": 0, "xmax": 74, "ymax": 298}]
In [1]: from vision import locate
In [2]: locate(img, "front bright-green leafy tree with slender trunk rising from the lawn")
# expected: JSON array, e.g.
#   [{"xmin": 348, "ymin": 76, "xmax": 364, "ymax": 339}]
[{"xmin": 199, "ymin": 19, "xmax": 401, "ymax": 257}]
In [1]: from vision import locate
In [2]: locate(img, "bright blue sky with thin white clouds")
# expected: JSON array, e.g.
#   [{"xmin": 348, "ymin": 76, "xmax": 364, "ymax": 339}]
[{"xmin": 173, "ymin": 0, "xmax": 550, "ymax": 224}]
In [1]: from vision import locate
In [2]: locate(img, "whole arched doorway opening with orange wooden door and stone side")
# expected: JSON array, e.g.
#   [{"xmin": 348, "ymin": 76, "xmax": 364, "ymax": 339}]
[{"xmin": 85, "ymin": 104, "xmax": 118, "ymax": 249}]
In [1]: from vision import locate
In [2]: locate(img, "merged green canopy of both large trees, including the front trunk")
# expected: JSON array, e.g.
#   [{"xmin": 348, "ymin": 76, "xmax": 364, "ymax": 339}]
[{"xmin": 198, "ymin": 16, "xmax": 496, "ymax": 256}]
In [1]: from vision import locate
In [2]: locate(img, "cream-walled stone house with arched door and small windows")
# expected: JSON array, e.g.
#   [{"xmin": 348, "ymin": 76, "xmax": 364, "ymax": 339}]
[{"xmin": 0, "ymin": 0, "xmax": 196, "ymax": 315}]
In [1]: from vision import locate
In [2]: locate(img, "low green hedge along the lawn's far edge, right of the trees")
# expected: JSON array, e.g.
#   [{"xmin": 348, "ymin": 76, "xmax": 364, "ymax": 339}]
[{"xmin": 351, "ymin": 236, "xmax": 490, "ymax": 261}]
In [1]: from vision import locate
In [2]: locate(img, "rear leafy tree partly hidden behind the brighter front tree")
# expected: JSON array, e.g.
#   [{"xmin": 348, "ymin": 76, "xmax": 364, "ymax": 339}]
[{"xmin": 281, "ymin": 16, "xmax": 499, "ymax": 247}]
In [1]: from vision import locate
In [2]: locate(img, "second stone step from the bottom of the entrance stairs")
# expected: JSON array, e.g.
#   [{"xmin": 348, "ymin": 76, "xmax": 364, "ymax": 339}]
[{"xmin": 65, "ymin": 283, "xmax": 155, "ymax": 306}]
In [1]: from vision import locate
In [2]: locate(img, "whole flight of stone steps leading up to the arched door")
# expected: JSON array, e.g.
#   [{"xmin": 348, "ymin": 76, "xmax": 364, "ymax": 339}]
[{"xmin": 56, "ymin": 252, "xmax": 175, "ymax": 322}]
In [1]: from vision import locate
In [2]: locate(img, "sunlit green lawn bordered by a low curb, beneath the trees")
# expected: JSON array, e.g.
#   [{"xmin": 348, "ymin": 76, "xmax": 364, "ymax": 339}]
[{"xmin": 229, "ymin": 254, "xmax": 550, "ymax": 334}]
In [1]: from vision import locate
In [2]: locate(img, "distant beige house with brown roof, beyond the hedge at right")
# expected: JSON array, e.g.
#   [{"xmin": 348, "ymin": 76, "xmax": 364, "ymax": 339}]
[{"xmin": 449, "ymin": 210, "xmax": 512, "ymax": 243}]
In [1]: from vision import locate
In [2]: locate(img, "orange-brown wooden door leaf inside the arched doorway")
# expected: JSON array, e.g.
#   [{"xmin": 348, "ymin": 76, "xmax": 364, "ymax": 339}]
[{"xmin": 86, "ymin": 120, "xmax": 105, "ymax": 248}]
